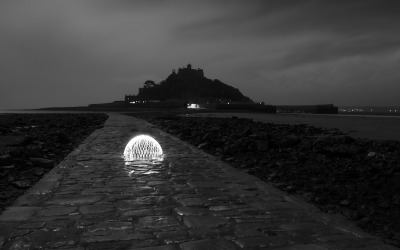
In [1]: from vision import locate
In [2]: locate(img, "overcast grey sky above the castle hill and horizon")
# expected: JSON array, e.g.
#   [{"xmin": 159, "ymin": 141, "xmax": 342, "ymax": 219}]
[{"xmin": 0, "ymin": 0, "xmax": 400, "ymax": 109}]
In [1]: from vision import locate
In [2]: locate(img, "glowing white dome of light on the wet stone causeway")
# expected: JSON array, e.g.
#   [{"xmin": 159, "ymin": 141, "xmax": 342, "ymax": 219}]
[{"xmin": 124, "ymin": 135, "xmax": 163, "ymax": 161}]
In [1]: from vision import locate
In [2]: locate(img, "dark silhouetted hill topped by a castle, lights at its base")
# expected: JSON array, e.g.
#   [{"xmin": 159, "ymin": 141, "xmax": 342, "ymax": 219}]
[{"xmin": 125, "ymin": 63, "xmax": 276, "ymax": 112}]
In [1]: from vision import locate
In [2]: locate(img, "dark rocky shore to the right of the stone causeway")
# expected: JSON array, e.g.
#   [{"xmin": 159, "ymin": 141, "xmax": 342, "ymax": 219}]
[{"xmin": 132, "ymin": 114, "xmax": 400, "ymax": 246}]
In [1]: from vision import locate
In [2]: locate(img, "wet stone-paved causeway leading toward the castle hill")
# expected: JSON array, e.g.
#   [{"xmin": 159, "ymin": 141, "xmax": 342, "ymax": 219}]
[{"xmin": 0, "ymin": 114, "xmax": 397, "ymax": 250}]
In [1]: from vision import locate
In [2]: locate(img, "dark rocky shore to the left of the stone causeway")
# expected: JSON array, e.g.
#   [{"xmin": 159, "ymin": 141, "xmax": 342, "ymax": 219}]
[{"xmin": 0, "ymin": 114, "xmax": 107, "ymax": 213}]
